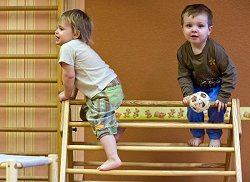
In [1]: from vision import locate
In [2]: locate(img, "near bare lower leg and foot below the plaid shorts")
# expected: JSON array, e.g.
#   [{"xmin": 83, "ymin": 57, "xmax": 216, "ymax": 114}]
[{"xmin": 97, "ymin": 135, "xmax": 122, "ymax": 171}]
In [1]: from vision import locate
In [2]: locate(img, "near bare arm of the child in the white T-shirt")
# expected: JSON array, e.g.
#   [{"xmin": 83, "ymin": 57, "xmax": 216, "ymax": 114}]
[{"xmin": 59, "ymin": 62, "xmax": 75, "ymax": 101}]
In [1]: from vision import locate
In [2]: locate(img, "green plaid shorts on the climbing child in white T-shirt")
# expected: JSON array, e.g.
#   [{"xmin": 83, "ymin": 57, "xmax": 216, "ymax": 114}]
[{"xmin": 80, "ymin": 78, "xmax": 124, "ymax": 140}]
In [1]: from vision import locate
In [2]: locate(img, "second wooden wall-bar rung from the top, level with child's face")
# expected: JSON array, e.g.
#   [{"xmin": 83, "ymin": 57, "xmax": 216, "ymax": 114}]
[{"xmin": 0, "ymin": 30, "xmax": 55, "ymax": 35}]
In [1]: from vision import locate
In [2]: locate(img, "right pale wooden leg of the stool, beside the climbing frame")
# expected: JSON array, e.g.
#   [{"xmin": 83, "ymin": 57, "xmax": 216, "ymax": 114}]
[{"xmin": 48, "ymin": 154, "xmax": 58, "ymax": 182}]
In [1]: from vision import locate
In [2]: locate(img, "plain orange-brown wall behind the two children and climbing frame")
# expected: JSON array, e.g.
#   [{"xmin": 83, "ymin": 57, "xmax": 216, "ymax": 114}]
[{"xmin": 85, "ymin": 0, "xmax": 250, "ymax": 182}]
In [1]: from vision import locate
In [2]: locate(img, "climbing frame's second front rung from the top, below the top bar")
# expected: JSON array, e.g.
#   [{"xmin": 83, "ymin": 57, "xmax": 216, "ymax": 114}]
[{"xmin": 69, "ymin": 121, "xmax": 233, "ymax": 129}]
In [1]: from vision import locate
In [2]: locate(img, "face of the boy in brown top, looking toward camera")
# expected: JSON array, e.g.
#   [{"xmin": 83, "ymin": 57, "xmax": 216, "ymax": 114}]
[{"xmin": 182, "ymin": 14, "xmax": 212, "ymax": 47}]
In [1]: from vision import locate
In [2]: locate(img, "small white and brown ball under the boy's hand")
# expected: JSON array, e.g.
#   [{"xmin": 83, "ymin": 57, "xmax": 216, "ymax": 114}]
[{"xmin": 189, "ymin": 92, "xmax": 210, "ymax": 113}]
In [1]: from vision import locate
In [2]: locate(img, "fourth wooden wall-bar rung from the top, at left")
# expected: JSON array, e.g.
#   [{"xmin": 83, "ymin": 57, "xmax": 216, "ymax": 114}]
[{"xmin": 0, "ymin": 78, "xmax": 57, "ymax": 83}]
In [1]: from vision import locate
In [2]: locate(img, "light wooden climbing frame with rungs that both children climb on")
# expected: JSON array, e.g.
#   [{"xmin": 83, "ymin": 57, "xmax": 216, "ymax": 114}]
[{"xmin": 60, "ymin": 99, "xmax": 242, "ymax": 182}]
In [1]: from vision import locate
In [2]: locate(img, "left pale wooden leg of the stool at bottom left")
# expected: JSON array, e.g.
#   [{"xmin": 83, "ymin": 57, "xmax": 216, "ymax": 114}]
[{"xmin": 6, "ymin": 160, "xmax": 18, "ymax": 182}]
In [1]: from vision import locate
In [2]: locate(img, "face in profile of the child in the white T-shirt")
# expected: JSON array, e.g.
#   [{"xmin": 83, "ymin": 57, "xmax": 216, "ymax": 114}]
[{"xmin": 55, "ymin": 22, "xmax": 77, "ymax": 45}]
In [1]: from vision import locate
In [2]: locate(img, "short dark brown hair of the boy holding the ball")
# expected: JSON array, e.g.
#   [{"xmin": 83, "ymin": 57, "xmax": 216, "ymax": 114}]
[{"xmin": 181, "ymin": 4, "xmax": 213, "ymax": 26}]
